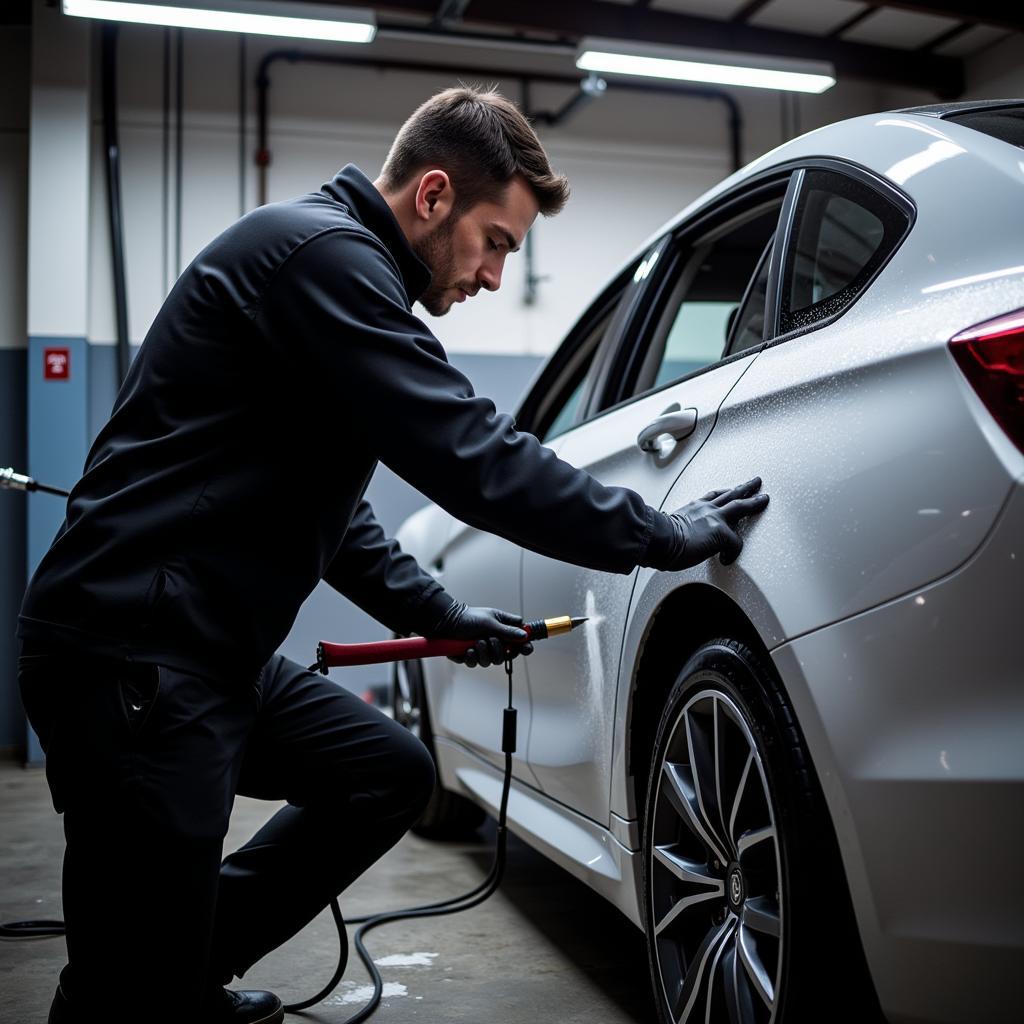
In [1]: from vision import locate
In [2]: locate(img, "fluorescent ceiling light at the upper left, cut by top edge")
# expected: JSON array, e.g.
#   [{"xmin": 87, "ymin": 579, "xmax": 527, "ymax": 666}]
[{"xmin": 60, "ymin": 0, "xmax": 377, "ymax": 43}]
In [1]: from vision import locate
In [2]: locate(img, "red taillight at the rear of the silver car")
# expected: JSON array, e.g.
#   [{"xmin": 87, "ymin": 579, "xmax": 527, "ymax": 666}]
[{"xmin": 949, "ymin": 309, "xmax": 1024, "ymax": 452}]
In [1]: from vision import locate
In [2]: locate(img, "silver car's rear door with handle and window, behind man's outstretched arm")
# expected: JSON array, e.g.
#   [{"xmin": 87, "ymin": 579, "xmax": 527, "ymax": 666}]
[{"xmin": 522, "ymin": 176, "xmax": 786, "ymax": 826}]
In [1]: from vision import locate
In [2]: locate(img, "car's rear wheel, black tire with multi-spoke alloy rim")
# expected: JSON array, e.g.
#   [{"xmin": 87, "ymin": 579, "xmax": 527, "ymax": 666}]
[{"xmin": 642, "ymin": 639, "xmax": 881, "ymax": 1024}]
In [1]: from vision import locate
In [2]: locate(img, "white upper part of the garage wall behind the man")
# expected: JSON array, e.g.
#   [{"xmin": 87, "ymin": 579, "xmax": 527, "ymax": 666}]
[{"xmin": 89, "ymin": 28, "xmax": 932, "ymax": 355}]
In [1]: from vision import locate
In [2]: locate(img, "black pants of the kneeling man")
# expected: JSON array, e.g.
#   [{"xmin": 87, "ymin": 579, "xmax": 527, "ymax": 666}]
[{"xmin": 18, "ymin": 651, "xmax": 434, "ymax": 1024}]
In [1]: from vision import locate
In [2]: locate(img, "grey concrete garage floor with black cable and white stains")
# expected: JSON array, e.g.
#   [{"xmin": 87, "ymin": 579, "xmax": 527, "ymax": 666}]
[{"xmin": 0, "ymin": 763, "xmax": 654, "ymax": 1024}]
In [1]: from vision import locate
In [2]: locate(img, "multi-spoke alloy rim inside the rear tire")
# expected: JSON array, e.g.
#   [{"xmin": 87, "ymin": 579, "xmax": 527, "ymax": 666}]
[{"xmin": 647, "ymin": 690, "xmax": 783, "ymax": 1024}]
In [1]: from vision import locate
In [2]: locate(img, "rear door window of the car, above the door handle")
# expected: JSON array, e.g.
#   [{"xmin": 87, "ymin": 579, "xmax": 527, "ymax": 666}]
[{"xmin": 636, "ymin": 198, "xmax": 781, "ymax": 393}]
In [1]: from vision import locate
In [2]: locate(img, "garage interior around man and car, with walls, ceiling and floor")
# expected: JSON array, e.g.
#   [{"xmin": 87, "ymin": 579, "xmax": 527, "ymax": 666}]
[{"xmin": 0, "ymin": 0, "xmax": 1024, "ymax": 1024}]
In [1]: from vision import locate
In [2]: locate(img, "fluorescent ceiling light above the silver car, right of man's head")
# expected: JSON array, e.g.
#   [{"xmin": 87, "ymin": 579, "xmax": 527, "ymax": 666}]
[{"xmin": 577, "ymin": 38, "xmax": 836, "ymax": 92}]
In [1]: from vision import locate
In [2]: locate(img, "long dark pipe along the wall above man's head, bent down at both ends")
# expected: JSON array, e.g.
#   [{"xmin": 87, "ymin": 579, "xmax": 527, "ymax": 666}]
[{"xmin": 256, "ymin": 46, "xmax": 742, "ymax": 206}]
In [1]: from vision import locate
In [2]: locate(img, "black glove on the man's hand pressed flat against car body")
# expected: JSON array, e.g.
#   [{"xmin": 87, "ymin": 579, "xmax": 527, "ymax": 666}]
[{"xmin": 655, "ymin": 476, "xmax": 768, "ymax": 571}]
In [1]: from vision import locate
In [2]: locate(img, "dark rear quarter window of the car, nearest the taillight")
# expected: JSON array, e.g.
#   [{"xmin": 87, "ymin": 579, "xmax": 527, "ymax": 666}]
[{"xmin": 779, "ymin": 170, "xmax": 907, "ymax": 334}]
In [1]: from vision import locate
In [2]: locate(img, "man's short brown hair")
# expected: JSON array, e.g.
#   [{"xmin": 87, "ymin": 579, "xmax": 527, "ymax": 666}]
[{"xmin": 381, "ymin": 85, "xmax": 569, "ymax": 217}]
